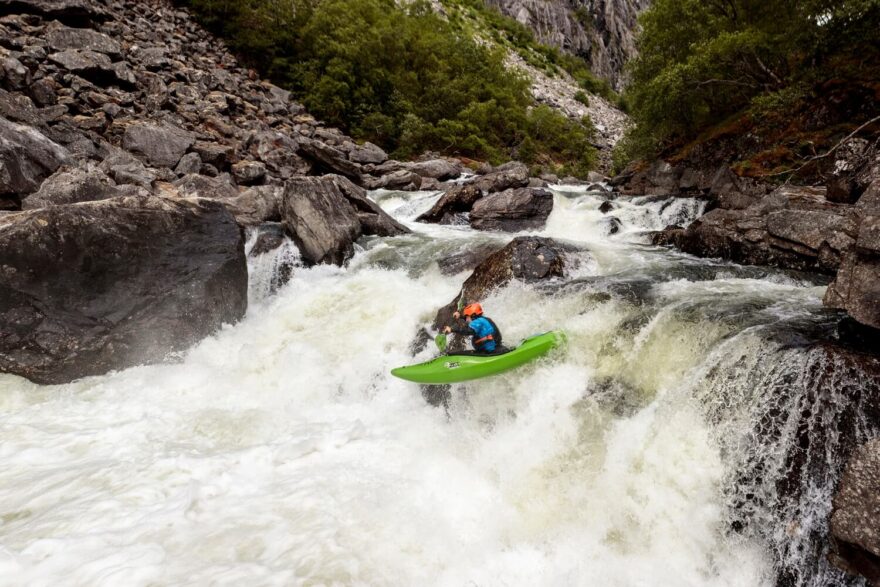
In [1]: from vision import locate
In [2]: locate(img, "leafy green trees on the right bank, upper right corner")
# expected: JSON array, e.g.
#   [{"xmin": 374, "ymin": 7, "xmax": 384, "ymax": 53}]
[{"xmin": 618, "ymin": 0, "xmax": 880, "ymax": 167}]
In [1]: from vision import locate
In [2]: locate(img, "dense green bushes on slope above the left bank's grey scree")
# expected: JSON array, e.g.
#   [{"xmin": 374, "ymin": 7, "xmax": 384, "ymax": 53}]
[{"xmin": 181, "ymin": 0, "xmax": 595, "ymax": 175}]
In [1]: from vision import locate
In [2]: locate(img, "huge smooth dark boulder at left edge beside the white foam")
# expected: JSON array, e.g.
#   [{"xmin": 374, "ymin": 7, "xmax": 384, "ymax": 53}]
[{"xmin": 0, "ymin": 197, "xmax": 247, "ymax": 383}]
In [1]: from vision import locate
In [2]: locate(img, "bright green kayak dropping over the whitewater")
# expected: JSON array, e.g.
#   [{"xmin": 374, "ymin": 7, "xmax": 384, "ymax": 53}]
[{"xmin": 391, "ymin": 330, "xmax": 565, "ymax": 383}]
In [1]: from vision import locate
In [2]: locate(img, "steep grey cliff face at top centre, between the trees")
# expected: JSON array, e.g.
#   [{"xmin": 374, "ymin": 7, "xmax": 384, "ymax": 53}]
[{"xmin": 485, "ymin": 0, "xmax": 650, "ymax": 90}]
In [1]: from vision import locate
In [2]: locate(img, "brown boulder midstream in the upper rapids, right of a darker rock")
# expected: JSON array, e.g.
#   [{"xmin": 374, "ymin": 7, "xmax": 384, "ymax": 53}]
[{"xmin": 470, "ymin": 188, "xmax": 553, "ymax": 232}]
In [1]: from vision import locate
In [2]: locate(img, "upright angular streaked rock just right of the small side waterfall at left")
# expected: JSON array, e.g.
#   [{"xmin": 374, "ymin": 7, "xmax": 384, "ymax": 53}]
[{"xmin": 281, "ymin": 177, "xmax": 362, "ymax": 265}]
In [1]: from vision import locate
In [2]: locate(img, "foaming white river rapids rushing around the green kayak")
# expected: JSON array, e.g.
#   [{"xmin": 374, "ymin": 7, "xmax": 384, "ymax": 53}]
[{"xmin": 0, "ymin": 187, "xmax": 852, "ymax": 587}]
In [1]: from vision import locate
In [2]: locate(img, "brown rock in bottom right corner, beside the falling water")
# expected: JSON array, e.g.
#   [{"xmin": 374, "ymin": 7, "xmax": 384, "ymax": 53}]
[{"xmin": 830, "ymin": 438, "xmax": 880, "ymax": 585}]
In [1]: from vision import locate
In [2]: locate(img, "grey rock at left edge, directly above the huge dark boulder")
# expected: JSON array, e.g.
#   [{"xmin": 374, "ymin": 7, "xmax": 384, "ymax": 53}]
[{"xmin": 0, "ymin": 118, "xmax": 71, "ymax": 197}]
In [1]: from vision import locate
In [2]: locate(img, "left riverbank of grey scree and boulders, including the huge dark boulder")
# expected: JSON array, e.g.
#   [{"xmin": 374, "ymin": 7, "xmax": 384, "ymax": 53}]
[{"xmin": 0, "ymin": 0, "xmax": 552, "ymax": 382}]
